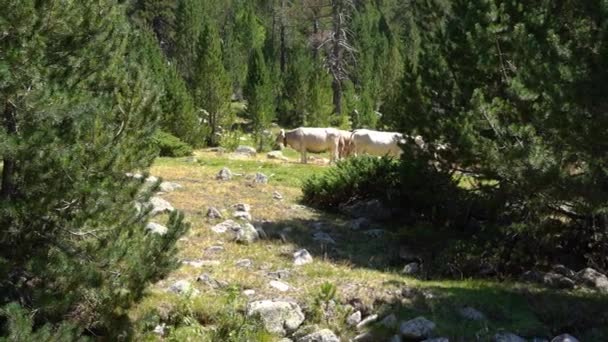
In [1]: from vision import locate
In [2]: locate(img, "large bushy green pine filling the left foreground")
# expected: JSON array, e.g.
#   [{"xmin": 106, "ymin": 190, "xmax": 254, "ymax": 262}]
[{"xmin": 0, "ymin": 0, "xmax": 186, "ymax": 338}]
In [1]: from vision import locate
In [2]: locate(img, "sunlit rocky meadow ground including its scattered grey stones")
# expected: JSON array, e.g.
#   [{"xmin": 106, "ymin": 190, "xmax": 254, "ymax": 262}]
[{"xmin": 130, "ymin": 149, "xmax": 608, "ymax": 342}]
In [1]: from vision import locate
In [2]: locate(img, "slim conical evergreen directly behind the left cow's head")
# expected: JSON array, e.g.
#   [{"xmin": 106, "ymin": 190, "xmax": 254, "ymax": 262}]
[{"xmin": 244, "ymin": 48, "xmax": 275, "ymax": 150}]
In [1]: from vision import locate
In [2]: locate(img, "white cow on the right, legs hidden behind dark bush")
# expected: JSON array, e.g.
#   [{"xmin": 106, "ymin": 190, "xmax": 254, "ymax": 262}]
[{"xmin": 351, "ymin": 129, "xmax": 405, "ymax": 157}]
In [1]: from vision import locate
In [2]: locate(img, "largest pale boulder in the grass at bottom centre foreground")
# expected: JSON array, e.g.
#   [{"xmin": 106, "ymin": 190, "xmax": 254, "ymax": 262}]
[{"xmin": 247, "ymin": 300, "xmax": 305, "ymax": 336}]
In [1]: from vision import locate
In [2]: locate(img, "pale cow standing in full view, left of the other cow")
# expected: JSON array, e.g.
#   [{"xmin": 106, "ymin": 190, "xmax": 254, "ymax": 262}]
[{"xmin": 276, "ymin": 127, "xmax": 340, "ymax": 164}]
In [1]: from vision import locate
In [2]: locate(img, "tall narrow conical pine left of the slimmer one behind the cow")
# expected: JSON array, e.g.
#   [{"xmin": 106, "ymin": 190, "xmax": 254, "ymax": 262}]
[{"xmin": 193, "ymin": 18, "xmax": 234, "ymax": 146}]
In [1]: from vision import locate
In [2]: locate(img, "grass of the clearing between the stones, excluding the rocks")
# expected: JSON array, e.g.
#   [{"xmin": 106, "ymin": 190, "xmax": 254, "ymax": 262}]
[{"xmin": 130, "ymin": 151, "xmax": 607, "ymax": 341}]
